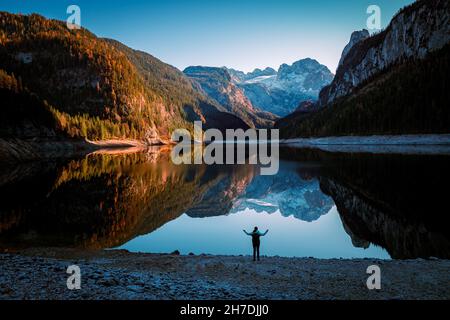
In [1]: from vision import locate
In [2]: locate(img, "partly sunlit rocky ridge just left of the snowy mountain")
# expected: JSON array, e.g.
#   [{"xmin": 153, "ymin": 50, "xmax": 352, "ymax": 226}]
[{"xmin": 184, "ymin": 66, "xmax": 276, "ymax": 128}]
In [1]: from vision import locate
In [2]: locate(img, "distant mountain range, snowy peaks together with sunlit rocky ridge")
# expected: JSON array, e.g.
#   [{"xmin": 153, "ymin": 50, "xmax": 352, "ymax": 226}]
[{"xmin": 183, "ymin": 58, "xmax": 334, "ymax": 127}]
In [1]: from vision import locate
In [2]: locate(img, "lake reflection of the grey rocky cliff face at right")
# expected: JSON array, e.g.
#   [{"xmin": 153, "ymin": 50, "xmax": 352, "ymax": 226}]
[{"xmin": 321, "ymin": 178, "xmax": 450, "ymax": 259}]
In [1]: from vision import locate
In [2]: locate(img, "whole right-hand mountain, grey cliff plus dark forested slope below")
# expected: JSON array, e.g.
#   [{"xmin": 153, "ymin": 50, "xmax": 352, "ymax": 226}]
[{"xmin": 276, "ymin": 0, "xmax": 450, "ymax": 138}]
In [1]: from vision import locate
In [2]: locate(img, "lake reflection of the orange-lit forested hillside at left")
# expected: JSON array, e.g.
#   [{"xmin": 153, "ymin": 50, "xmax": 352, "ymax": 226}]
[{"xmin": 0, "ymin": 150, "xmax": 254, "ymax": 248}]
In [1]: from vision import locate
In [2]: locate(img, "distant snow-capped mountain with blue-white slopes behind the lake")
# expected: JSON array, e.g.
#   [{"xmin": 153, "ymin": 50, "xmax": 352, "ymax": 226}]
[{"xmin": 227, "ymin": 58, "xmax": 334, "ymax": 116}]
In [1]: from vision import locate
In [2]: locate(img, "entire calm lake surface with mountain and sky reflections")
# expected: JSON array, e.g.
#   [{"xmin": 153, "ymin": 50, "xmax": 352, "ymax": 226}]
[{"xmin": 0, "ymin": 148, "xmax": 450, "ymax": 259}]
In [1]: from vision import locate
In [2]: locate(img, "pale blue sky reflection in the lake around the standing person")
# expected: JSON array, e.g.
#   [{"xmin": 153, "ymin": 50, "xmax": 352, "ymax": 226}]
[{"xmin": 120, "ymin": 207, "xmax": 390, "ymax": 259}]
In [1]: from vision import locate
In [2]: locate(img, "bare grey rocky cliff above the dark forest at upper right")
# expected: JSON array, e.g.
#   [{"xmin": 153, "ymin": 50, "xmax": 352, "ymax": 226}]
[{"xmin": 320, "ymin": 0, "xmax": 450, "ymax": 106}]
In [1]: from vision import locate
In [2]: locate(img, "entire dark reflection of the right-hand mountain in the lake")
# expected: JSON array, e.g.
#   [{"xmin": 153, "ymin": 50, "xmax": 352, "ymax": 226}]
[{"xmin": 289, "ymin": 150, "xmax": 450, "ymax": 259}]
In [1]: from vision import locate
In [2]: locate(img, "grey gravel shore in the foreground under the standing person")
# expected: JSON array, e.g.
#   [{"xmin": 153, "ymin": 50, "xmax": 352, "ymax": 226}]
[{"xmin": 0, "ymin": 248, "xmax": 450, "ymax": 300}]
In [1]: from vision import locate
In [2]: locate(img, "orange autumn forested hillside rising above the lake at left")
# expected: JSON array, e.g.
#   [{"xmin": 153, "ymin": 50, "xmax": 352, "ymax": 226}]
[{"xmin": 0, "ymin": 12, "xmax": 245, "ymax": 143}]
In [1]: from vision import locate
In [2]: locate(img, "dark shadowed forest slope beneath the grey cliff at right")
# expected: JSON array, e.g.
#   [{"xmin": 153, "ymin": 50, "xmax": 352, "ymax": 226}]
[{"xmin": 277, "ymin": 45, "xmax": 450, "ymax": 137}]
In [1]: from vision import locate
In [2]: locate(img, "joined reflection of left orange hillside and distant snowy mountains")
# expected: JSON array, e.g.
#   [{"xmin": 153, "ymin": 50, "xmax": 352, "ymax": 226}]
[{"xmin": 0, "ymin": 150, "xmax": 332, "ymax": 248}]
